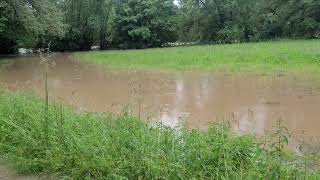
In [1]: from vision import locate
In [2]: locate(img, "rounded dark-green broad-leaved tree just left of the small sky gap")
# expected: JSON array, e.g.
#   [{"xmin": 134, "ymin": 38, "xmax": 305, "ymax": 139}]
[{"xmin": 114, "ymin": 0, "xmax": 176, "ymax": 48}]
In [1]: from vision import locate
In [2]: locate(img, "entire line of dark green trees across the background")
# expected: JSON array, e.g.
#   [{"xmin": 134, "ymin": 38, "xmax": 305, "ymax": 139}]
[{"xmin": 0, "ymin": 0, "xmax": 320, "ymax": 53}]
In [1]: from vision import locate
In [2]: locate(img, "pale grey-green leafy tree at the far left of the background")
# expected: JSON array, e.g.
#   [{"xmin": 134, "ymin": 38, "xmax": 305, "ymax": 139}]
[{"xmin": 0, "ymin": 0, "xmax": 65, "ymax": 53}]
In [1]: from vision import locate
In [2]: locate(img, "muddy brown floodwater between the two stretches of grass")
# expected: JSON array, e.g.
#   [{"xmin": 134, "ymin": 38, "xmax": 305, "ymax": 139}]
[{"xmin": 0, "ymin": 54, "xmax": 320, "ymax": 148}]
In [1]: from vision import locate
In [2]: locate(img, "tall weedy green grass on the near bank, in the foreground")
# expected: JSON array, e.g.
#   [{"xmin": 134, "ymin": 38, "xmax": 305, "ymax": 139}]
[{"xmin": 0, "ymin": 90, "xmax": 320, "ymax": 179}]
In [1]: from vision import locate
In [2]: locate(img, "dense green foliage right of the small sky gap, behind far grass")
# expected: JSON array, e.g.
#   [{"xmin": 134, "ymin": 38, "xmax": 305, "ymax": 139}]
[{"xmin": 179, "ymin": 0, "xmax": 320, "ymax": 43}]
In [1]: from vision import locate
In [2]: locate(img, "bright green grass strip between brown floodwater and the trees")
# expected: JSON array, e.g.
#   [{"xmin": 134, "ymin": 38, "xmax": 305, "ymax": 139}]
[{"xmin": 74, "ymin": 40, "xmax": 320, "ymax": 73}]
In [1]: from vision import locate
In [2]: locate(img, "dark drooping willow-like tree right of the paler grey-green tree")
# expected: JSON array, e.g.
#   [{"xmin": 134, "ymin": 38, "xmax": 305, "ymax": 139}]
[{"xmin": 48, "ymin": 0, "xmax": 113, "ymax": 50}]
